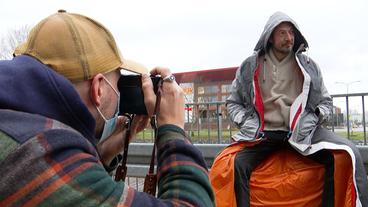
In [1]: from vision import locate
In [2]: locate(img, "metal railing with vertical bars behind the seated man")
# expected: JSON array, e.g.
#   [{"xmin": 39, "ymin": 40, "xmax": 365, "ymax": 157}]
[{"xmin": 137, "ymin": 93, "xmax": 368, "ymax": 145}]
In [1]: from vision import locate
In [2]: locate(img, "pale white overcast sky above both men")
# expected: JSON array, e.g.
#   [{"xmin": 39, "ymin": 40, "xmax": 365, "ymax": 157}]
[{"xmin": 0, "ymin": 0, "xmax": 368, "ymax": 102}]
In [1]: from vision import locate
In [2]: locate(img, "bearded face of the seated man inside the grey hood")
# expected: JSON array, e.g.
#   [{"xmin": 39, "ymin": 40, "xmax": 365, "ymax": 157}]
[{"xmin": 270, "ymin": 22, "xmax": 295, "ymax": 54}]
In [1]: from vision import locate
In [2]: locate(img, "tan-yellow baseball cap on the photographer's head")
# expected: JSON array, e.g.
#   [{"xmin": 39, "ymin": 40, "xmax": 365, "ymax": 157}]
[{"xmin": 14, "ymin": 10, "xmax": 148, "ymax": 82}]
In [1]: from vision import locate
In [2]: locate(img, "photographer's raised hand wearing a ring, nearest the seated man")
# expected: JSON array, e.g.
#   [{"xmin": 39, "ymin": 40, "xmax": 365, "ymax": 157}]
[{"xmin": 142, "ymin": 67, "xmax": 184, "ymax": 129}]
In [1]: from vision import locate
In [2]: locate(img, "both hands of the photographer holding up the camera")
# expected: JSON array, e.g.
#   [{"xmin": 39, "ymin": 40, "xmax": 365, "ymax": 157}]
[{"xmin": 97, "ymin": 68, "xmax": 184, "ymax": 166}]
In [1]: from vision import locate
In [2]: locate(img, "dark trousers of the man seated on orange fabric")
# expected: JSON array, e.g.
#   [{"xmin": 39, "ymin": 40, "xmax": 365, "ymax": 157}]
[{"xmin": 234, "ymin": 131, "xmax": 334, "ymax": 207}]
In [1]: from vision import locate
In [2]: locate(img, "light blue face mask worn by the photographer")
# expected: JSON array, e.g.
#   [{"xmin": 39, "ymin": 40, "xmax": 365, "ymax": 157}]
[{"xmin": 96, "ymin": 78, "xmax": 120, "ymax": 142}]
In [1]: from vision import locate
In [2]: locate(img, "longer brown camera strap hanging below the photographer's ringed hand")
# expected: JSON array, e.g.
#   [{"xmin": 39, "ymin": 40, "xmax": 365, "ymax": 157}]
[{"xmin": 143, "ymin": 80, "xmax": 162, "ymax": 196}]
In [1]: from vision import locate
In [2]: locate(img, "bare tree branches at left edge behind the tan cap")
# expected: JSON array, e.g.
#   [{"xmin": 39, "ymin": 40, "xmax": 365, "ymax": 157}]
[{"xmin": 0, "ymin": 25, "xmax": 31, "ymax": 60}]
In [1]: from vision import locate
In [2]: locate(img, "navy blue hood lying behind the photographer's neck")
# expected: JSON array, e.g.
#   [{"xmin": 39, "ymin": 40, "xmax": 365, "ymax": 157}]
[{"xmin": 0, "ymin": 55, "xmax": 96, "ymax": 145}]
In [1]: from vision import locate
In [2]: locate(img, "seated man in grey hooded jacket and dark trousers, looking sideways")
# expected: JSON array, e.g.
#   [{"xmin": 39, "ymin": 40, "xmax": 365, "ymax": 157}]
[{"xmin": 211, "ymin": 12, "xmax": 368, "ymax": 207}]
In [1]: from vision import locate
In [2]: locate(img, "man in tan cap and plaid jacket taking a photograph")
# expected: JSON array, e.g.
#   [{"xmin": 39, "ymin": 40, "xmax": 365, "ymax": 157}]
[{"xmin": 0, "ymin": 10, "xmax": 214, "ymax": 206}]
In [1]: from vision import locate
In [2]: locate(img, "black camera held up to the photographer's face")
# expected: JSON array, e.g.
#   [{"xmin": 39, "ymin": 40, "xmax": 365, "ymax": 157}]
[{"xmin": 118, "ymin": 75, "xmax": 161, "ymax": 115}]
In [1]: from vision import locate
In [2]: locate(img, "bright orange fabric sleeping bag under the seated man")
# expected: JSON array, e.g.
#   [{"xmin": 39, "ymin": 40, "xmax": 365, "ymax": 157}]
[{"xmin": 210, "ymin": 143, "xmax": 355, "ymax": 207}]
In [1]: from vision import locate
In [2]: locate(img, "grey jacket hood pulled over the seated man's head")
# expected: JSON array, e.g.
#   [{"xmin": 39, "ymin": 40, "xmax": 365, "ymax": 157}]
[{"xmin": 254, "ymin": 12, "xmax": 308, "ymax": 52}]
